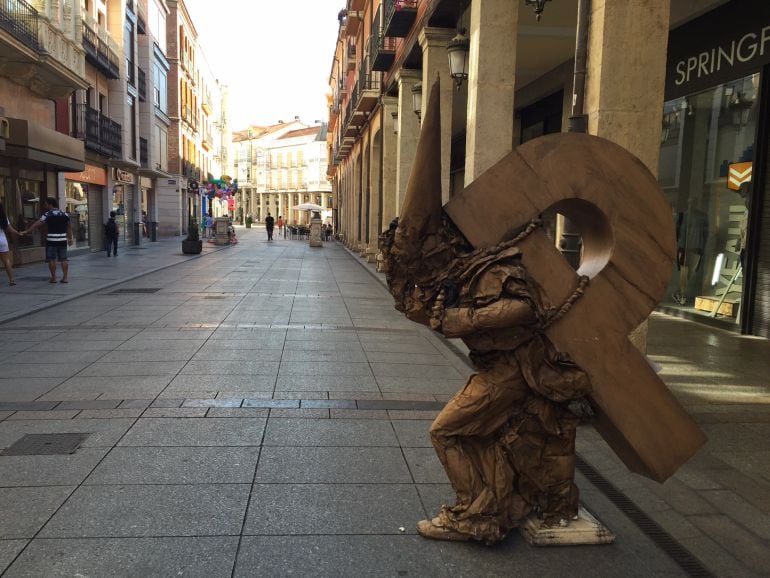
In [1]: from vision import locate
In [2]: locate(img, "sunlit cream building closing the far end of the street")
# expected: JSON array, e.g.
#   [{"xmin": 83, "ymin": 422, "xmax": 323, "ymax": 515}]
[{"xmin": 233, "ymin": 118, "xmax": 333, "ymax": 225}]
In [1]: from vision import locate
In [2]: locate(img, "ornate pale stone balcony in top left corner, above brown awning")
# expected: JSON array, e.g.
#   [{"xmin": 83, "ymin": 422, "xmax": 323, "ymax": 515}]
[{"xmin": 0, "ymin": 0, "xmax": 88, "ymax": 98}]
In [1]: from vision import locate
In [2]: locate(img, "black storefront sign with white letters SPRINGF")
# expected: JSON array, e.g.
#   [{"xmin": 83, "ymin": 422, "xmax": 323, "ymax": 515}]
[{"xmin": 665, "ymin": 0, "xmax": 770, "ymax": 100}]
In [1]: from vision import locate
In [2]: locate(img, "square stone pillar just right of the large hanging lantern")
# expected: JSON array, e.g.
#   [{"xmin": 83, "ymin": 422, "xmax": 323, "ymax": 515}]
[{"xmin": 462, "ymin": 0, "xmax": 519, "ymax": 186}]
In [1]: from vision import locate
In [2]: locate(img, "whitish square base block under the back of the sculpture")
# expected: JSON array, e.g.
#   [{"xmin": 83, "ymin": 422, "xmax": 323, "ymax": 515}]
[{"xmin": 519, "ymin": 506, "xmax": 615, "ymax": 546}]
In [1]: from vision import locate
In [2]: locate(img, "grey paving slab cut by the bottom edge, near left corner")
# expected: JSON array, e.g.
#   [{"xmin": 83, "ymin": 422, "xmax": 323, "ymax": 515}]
[{"xmin": 0, "ymin": 536, "xmax": 238, "ymax": 578}]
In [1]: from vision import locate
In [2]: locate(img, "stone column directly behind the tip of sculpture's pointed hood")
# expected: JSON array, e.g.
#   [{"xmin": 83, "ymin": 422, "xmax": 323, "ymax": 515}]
[{"xmin": 410, "ymin": 27, "xmax": 452, "ymax": 203}]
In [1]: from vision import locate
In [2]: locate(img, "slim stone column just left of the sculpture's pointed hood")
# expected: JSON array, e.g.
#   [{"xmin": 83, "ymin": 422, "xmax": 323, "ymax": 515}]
[{"xmin": 396, "ymin": 68, "xmax": 424, "ymax": 214}]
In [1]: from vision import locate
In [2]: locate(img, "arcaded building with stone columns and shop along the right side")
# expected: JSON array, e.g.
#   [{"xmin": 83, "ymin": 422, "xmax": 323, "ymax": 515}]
[{"xmin": 328, "ymin": 0, "xmax": 770, "ymax": 337}]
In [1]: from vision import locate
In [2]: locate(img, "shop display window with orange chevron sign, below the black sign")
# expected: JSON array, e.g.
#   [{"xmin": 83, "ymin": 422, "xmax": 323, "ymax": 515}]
[{"xmin": 659, "ymin": 74, "xmax": 759, "ymax": 323}]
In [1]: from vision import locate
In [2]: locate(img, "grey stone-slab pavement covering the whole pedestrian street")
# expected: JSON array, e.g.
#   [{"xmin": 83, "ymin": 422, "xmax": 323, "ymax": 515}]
[{"xmin": 0, "ymin": 228, "xmax": 770, "ymax": 577}]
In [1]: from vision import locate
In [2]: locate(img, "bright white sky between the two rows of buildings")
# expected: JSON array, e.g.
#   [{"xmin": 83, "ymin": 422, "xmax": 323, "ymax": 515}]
[{"xmin": 185, "ymin": 0, "xmax": 346, "ymax": 131}]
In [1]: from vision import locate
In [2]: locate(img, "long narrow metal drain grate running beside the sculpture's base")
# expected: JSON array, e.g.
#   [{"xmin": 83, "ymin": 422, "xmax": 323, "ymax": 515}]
[{"xmin": 575, "ymin": 456, "xmax": 714, "ymax": 577}]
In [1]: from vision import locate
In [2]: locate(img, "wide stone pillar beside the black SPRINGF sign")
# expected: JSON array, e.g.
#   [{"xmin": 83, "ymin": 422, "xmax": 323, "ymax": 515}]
[{"xmin": 585, "ymin": 0, "xmax": 670, "ymax": 351}]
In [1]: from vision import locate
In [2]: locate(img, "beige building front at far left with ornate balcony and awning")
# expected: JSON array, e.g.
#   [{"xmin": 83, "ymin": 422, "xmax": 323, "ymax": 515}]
[{"xmin": 0, "ymin": 0, "xmax": 86, "ymax": 264}]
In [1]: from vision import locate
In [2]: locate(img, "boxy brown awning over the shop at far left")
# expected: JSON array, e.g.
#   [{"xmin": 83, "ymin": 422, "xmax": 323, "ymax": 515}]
[{"xmin": 3, "ymin": 118, "xmax": 86, "ymax": 172}]
